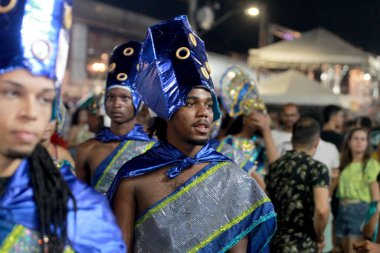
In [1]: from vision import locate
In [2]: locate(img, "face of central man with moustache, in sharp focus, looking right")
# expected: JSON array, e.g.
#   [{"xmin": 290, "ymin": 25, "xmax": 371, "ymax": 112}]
[{"xmin": 168, "ymin": 88, "xmax": 214, "ymax": 145}]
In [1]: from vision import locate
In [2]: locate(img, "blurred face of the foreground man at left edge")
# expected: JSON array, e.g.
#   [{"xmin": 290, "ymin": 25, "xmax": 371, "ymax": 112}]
[{"xmin": 0, "ymin": 70, "xmax": 55, "ymax": 158}]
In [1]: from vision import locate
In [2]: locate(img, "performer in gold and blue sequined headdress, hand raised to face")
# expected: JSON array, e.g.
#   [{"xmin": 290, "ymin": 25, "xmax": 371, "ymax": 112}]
[{"xmin": 220, "ymin": 66, "xmax": 278, "ymax": 185}]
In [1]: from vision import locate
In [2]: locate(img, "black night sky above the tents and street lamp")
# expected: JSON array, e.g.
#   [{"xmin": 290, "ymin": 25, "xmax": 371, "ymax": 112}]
[{"xmin": 95, "ymin": 0, "xmax": 380, "ymax": 54}]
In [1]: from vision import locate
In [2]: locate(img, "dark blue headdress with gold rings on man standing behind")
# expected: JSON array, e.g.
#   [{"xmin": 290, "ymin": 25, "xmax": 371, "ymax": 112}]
[{"xmin": 106, "ymin": 41, "xmax": 141, "ymax": 115}]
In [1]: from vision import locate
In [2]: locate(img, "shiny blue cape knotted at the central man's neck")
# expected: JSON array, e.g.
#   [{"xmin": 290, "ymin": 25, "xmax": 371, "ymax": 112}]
[{"xmin": 107, "ymin": 142, "xmax": 231, "ymax": 201}]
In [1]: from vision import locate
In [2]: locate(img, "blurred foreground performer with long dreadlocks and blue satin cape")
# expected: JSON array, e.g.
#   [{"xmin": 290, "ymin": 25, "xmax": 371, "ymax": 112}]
[{"xmin": 0, "ymin": 0, "xmax": 126, "ymax": 253}]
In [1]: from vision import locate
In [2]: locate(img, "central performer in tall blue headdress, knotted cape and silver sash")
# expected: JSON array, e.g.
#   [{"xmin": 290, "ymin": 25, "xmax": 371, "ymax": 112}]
[{"xmin": 107, "ymin": 16, "xmax": 276, "ymax": 252}]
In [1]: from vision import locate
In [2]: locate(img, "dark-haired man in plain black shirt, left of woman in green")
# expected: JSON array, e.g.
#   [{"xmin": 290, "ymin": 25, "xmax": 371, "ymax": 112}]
[{"xmin": 321, "ymin": 105, "xmax": 344, "ymax": 151}]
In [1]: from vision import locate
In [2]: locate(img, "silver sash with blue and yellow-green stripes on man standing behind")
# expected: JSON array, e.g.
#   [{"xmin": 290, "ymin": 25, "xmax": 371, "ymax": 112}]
[{"xmin": 91, "ymin": 140, "xmax": 155, "ymax": 194}]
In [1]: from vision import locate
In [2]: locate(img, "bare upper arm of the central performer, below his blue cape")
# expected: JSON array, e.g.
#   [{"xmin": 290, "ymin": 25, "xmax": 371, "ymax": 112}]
[{"xmin": 112, "ymin": 179, "xmax": 136, "ymax": 252}]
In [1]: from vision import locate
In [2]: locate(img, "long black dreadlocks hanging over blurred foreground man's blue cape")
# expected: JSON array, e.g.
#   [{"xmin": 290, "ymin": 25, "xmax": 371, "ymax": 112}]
[{"xmin": 29, "ymin": 144, "xmax": 76, "ymax": 253}]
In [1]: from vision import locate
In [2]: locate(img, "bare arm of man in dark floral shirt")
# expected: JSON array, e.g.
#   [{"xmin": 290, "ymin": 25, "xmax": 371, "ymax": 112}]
[{"xmin": 313, "ymin": 187, "xmax": 330, "ymax": 242}]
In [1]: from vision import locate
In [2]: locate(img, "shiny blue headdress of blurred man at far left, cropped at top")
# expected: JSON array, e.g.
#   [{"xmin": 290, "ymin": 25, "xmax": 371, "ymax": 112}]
[{"xmin": 0, "ymin": 0, "xmax": 72, "ymax": 87}]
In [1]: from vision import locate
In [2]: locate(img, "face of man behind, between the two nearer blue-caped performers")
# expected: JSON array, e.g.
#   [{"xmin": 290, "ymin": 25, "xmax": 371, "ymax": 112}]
[{"xmin": 106, "ymin": 88, "xmax": 134, "ymax": 124}]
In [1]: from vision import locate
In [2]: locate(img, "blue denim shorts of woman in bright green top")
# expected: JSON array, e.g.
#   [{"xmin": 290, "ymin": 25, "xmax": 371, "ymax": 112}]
[{"xmin": 335, "ymin": 201, "xmax": 369, "ymax": 237}]
